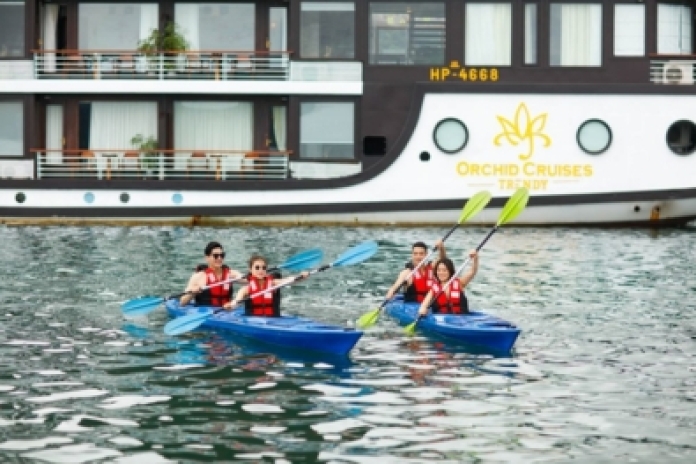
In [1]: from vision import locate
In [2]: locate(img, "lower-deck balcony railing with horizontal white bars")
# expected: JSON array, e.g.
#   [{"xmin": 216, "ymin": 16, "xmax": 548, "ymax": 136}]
[{"xmin": 32, "ymin": 149, "xmax": 292, "ymax": 181}]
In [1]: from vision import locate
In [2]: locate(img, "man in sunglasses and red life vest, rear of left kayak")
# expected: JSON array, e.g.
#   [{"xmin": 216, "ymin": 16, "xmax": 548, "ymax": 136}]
[{"xmin": 179, "ymin": 242, "xmax": 244, "ymax": 307}]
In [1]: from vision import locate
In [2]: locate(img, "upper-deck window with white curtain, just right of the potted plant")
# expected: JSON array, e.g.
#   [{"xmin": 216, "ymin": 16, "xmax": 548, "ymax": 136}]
[{"xmin": 174, "ymin": 3, "xmax": 256, "ymax": 51}]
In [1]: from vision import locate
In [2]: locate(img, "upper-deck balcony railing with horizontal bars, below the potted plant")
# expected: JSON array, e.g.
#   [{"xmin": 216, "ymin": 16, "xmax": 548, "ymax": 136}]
[{"xmin": 33, "ymin": 50, "xmax": 291, "ymax": 80}]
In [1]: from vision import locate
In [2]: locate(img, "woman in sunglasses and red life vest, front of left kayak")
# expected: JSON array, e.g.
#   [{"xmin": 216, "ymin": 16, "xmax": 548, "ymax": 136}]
[{"xmin": 224, "ymin": 256, "xmax": 309, "ymax": 317}]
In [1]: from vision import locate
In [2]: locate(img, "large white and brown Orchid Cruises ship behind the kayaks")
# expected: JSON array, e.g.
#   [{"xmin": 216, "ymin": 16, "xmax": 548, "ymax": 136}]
[{"xmin": 0, "ymin": 0, "xmax": 696, "ymax": 226}]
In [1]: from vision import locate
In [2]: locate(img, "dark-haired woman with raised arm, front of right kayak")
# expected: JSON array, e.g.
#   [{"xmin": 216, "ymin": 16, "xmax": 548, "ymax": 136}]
[{"xmin": 418, "ymin": 250, "xmax": 478, "ymax": 316}]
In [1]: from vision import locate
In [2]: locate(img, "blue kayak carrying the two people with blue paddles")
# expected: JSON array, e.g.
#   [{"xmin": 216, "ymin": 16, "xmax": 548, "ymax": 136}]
[{"xmin": 165, "ymin": 299, "xmax": 363, "ymax": 356}]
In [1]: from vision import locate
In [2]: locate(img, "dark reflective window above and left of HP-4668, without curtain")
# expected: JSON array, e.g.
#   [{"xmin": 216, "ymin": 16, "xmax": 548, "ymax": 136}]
[{"xmin": 370, "ymin": 2, "xmax": 445, "ymax": 65}]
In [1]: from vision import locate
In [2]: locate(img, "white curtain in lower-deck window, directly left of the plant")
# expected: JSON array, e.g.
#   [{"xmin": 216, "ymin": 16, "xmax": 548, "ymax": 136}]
[{"xmin": 89, "ymin": 102, "xmax": 157, "ymax": 152}]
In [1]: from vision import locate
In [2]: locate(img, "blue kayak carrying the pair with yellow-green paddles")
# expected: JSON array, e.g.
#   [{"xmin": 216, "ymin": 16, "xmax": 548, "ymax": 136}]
[{"xmin": 385, "ymin": 299, "xmax": 521, "ymax": 352}]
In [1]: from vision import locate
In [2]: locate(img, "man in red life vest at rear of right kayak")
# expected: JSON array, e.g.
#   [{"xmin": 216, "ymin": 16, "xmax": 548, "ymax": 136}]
[{"xmin": 387, "ymin": 240, "xmax": 447, "ymax": 303}]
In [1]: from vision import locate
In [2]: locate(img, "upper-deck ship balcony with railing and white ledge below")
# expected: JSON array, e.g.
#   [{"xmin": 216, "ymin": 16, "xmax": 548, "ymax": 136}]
[{"xmin": 0, "ymin": 50, "xmax": 363, "ymax": 95}]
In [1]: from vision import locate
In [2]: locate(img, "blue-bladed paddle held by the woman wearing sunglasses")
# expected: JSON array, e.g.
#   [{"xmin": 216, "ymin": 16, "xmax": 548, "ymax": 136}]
[{"xmin": 164, "ymin": 241, "xmax": 379, "ymax": 335}]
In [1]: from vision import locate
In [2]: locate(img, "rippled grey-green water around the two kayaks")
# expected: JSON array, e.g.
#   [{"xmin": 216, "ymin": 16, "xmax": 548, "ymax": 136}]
[{"xmin": 0, "ymin": 226, "xmax": 696, "ymax": 464}]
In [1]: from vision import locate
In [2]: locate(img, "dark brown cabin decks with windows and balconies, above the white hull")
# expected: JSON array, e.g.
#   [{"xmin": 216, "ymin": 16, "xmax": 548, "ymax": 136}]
[{"xmin": 0, "ymin": 0, "xmax": 696, "ymax": 189}]
